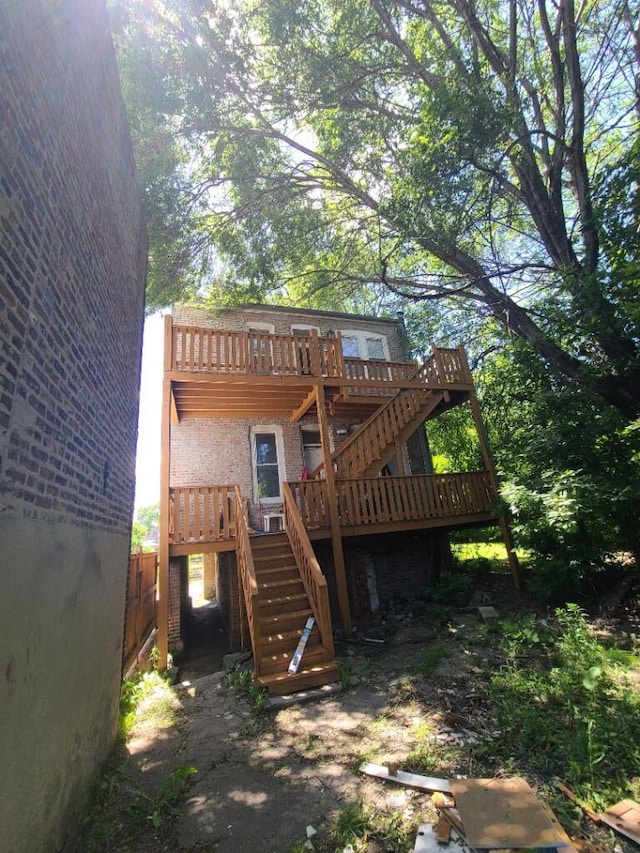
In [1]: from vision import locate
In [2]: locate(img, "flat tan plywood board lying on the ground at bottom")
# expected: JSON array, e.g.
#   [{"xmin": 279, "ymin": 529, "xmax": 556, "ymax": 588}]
[{"xmin": 451, "ymin": 777, "xmax": 566, "ymax": 850}]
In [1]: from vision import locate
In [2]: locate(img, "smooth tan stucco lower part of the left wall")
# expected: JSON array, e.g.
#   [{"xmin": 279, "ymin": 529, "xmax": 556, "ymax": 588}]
[{"xmin": 0, "ymin": 510, "xmax": 129, "ymax": 853}]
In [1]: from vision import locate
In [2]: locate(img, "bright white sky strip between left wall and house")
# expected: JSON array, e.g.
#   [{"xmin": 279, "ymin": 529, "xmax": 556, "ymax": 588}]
[{"xmin": 135, "ymin": 314, "xmax": 164, "ymax": 512}]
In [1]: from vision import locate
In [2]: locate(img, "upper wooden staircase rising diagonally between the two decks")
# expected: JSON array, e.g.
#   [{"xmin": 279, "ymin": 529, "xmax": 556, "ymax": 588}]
[{"xmin": 331, "ymin": 388, "xmax": 447, "ymax": 480}]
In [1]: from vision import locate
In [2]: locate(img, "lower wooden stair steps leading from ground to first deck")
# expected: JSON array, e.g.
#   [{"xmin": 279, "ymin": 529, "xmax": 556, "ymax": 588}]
[{"xmin": 251, "ymin": 533, "xmax": 340, "ymax": 695}]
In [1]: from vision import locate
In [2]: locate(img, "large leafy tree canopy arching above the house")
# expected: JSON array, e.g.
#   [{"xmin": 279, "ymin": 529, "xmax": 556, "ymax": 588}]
[{"xmin": 111, "ymin": 0, "xmax": 640, "ymax": 418}]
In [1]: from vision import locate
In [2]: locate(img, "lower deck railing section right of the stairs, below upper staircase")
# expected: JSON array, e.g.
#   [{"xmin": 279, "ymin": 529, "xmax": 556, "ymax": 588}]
[{"xmin": 336, "ymin": 471, "xmax": 496, "ymax": 527}]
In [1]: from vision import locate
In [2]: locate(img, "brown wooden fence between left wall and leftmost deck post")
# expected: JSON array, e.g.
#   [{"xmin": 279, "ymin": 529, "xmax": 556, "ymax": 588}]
[{"xmin": 122, "ymin": 550, "xmax": 158, "ymax": 671}]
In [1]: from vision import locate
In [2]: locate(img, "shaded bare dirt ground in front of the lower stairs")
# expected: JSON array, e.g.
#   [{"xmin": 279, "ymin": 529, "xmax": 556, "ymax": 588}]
[{"xmin": 81, "ymin": 587, "xmax": 640, "ymax": 853}]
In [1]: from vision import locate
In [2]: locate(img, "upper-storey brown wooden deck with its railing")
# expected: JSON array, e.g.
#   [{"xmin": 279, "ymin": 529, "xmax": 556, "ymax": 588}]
[{"xmin": 165, "ymin": 318, "xmax": 473, "ymax": 422}]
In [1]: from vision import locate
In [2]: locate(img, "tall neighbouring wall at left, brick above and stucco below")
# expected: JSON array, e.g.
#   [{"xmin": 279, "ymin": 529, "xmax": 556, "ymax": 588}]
[{"xmin": 0, "ymin": 0, "xmax": 146, "ymax": 853}]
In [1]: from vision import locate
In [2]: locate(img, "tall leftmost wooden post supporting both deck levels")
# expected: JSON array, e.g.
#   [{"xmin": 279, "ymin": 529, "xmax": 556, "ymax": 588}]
[{"xmin": 158, "ymin": 316, "xmax": 173, "ymax": 669}]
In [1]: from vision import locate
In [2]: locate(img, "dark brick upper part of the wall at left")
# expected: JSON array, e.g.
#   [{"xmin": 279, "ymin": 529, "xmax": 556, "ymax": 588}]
[{"xmin": 0, "ymin": 0, "xmax": 146, "ymax": 533}]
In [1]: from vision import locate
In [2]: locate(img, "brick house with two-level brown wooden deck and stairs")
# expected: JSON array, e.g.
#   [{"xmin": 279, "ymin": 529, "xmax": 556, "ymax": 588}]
[{"xmin": 159, "ymin": 306, "xmax": 519, "ymax": 693}]
